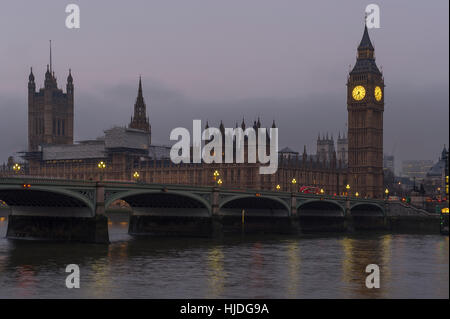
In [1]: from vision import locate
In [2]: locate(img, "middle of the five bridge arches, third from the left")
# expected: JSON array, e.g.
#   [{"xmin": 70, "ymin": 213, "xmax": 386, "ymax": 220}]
[{"xmin": 219, "ymin": 195, "xmax": 291, "ymax": 216}]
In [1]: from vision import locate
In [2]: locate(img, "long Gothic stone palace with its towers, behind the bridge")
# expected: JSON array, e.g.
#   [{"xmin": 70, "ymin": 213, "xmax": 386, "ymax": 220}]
[{"xmin": 4, "ymin": 22, "xmax": 384, "ymax": 198}]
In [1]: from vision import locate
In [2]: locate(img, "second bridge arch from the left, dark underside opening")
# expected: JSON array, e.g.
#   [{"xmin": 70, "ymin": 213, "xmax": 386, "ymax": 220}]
[{"xmin": 105, "ymin": 190, "xmax": 211, "ymax": 215}]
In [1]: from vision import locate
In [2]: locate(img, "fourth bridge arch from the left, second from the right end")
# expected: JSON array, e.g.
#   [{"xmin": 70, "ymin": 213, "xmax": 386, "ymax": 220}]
[{"xmin": 297, "ymin": 199, "xmax": 345, "ymax": 217}]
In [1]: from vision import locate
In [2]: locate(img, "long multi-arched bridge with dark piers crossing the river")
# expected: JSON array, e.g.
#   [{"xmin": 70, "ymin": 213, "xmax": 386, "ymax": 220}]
[{"xmin": 0, "ymin": 177, "xmax": 387, "ymax": 243}]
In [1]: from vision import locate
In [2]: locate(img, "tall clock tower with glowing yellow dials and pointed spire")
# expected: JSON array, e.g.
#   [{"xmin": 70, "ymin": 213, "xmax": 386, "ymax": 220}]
[{"xmin": 347, "ymin": 25, "xmax": 384, "ymax": 198}]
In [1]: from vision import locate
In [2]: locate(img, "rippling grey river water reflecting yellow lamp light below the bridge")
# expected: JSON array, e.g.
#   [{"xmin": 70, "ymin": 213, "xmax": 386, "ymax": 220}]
[{"xmin": 0, "ymin": 218, "xmax": 449, "ymax": 299}]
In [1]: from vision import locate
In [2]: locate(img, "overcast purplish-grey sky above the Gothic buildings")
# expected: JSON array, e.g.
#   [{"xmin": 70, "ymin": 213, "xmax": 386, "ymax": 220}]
[{"xmin": 0, "ymin": 0, "xmax": 449, "ymax": 169}]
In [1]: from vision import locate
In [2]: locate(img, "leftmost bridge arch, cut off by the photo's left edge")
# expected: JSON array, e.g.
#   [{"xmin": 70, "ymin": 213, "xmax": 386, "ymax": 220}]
[{"xmin": 0, "ymin": 185, "xmax": 95, "ymax": 216}]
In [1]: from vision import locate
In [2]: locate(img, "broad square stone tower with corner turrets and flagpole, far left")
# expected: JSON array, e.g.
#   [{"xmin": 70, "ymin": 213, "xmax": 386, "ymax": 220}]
[{"xmin": 28, "ymin": 48, "xmax": 74, "ymax": 152}]
